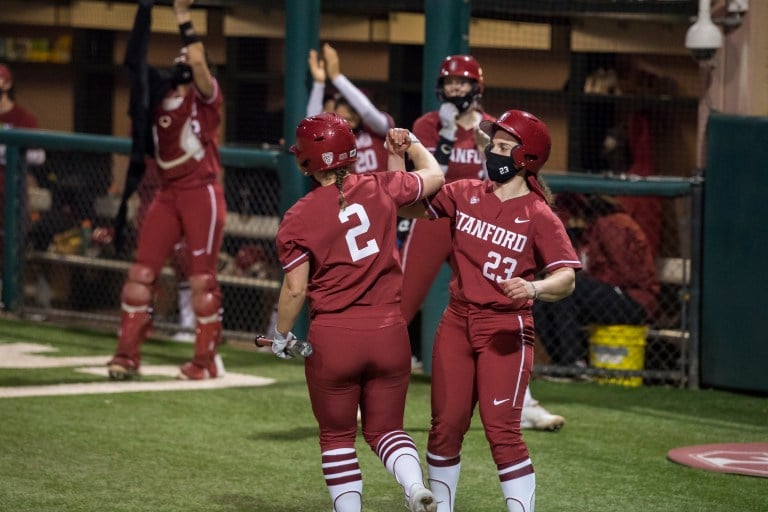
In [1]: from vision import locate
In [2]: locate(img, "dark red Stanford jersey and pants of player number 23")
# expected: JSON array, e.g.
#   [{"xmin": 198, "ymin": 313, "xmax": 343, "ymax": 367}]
[{"xmin": 428, "ymin": 180, "xmax": 581, "ymax": 464}]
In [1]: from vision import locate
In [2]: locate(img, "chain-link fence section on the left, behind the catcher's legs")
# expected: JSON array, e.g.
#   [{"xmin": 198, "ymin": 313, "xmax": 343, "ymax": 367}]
[{"xmin": 0, "ymin": 132, "xmax": 281, "ymax": 337}]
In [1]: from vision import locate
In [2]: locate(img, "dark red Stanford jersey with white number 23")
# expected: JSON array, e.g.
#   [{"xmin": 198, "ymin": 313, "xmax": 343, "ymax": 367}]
[{"xmin": 424, "ymin": 180, "xmax": 581, "ymax": 311}]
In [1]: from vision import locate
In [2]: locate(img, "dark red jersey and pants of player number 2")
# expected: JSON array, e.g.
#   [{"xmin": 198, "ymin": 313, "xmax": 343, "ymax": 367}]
[{"xmin": 277, "ymin": 171, "xmax": 423, "ymax": 451}]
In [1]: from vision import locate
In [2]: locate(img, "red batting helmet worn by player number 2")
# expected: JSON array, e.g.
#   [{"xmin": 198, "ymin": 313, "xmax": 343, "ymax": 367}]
[{"xmin": 290, "ymin": 112, "xmax": 357, "ymax": 173}]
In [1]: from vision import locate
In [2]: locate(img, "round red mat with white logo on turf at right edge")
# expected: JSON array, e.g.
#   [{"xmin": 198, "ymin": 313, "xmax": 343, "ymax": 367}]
[{"xmin": 667, "ymin": 443, "xmax": 768, "ymax": 478}]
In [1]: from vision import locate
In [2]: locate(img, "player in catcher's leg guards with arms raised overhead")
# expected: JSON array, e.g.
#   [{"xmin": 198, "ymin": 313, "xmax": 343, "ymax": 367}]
[{"xmin": 107, "ymin": 0, "xmax": 226, "ymax": 380}]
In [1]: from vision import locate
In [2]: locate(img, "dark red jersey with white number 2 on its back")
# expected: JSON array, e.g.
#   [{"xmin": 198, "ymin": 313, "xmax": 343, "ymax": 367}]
[{"xmin": 276, "ymin": 171, "xmax": 424, "ymax": 318}]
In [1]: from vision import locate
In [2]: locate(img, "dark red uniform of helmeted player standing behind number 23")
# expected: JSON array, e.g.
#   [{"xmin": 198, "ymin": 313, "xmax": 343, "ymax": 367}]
[{"xmin": 401, "ymin": 112, "xmax": 493, "ymax": 322}]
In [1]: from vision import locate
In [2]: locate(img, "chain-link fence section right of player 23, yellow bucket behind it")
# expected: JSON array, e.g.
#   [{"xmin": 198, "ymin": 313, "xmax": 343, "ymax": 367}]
[{"xmin": 534, "ymin": 181, "xmax": 698, "ymax": 385}]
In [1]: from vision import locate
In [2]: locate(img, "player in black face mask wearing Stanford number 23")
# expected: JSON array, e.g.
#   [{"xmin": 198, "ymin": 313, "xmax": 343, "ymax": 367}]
[{"xmin": 402, "ymin": 110, "xmax": 581, "ymax": 512}]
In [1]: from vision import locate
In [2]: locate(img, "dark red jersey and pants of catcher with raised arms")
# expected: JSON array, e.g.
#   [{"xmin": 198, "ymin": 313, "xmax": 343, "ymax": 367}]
[{"xmin": 136, "ymin": 81, "xmax": 226, "ymax": 276}]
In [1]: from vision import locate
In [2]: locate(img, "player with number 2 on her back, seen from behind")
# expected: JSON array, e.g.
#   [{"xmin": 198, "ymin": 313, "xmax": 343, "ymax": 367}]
[{"xmin": 272, "ymin": 113, "xmax": 444, "ymax": 512}]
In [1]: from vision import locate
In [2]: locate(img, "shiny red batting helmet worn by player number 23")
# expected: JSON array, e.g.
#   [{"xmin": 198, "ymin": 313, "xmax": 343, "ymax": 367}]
[{"xmin": 480, "ymin": 110, "xmax": 552, "ymax": 174}]
